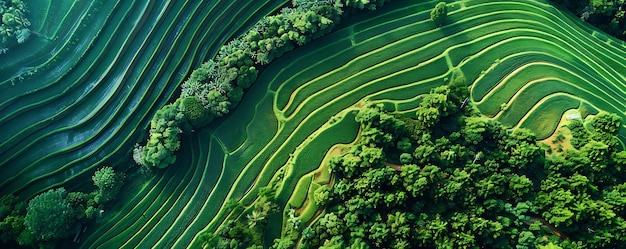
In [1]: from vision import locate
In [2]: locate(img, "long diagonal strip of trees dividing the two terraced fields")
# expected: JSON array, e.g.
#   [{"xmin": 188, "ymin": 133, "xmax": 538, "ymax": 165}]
[{"xmin": 133, "ymin": 0, "xmax": 389, "ymax": 168}]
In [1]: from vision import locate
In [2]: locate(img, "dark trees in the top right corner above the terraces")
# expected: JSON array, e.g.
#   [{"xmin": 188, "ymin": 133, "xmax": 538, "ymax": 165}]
[{"xmin": 551, "ymin": 0, "xmax": 626, "ymax": 40}]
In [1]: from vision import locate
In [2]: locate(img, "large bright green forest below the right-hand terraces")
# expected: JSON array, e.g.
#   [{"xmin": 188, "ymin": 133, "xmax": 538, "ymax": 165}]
[{"xmin": 297, "ymin": 80, "xmax": 626, "ymax": 249}]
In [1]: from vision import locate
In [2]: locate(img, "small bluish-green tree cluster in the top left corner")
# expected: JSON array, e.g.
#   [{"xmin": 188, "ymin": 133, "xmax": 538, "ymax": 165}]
[{"xmin": 0, "ymin": 0, "xmax": 31, "ymax": 54}]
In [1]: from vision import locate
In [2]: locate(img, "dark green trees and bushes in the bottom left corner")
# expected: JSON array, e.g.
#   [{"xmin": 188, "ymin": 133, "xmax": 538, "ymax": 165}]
[{"xmin": 0, "ymin": 166, "xmax": 125, "ymax": 248}]
